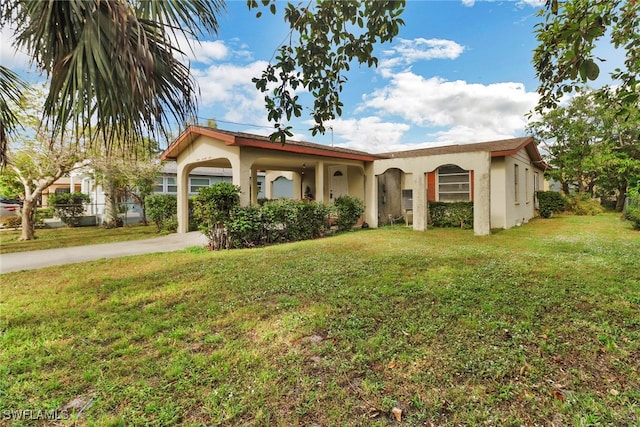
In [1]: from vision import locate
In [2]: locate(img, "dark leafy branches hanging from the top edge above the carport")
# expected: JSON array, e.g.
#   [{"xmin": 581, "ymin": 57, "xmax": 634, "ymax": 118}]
[{"xmin": 247, "ymin": 0, "xmax": 405, "ymax": 143}]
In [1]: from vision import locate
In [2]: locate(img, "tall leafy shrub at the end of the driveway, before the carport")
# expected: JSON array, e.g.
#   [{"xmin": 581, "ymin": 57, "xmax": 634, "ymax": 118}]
[{"xmin": 193, "ymin": 182, "xmax": 240, "ymax": 250}]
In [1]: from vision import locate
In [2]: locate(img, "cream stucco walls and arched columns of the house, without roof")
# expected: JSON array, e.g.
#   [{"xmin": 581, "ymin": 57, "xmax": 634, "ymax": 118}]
[{"xmin": 172, "ymin": 135, "xmax": 543, "ymax": 235}]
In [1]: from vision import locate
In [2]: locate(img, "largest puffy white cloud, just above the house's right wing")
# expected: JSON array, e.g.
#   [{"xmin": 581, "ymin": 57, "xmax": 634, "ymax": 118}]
[{"xmin": 358, "ymin": 71, "xmax": 538, "ymax": 143}]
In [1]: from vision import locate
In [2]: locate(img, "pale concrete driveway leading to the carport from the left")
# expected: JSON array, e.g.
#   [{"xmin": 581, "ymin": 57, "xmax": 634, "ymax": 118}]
[{"xmin": 0, "ymin": 231, "xmax": 207, "ymax": 274}]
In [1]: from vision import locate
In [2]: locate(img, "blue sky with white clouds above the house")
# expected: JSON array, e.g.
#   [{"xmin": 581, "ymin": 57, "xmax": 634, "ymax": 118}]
[{"xmin": 0, "ymin": 0, "xmax": 615, "ymax": 152}]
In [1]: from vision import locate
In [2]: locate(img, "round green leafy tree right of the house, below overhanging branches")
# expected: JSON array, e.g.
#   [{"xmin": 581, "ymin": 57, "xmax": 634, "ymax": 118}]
[{"xmin": 528, "ymin": 87, "xmax": 640, "ymax": 209}]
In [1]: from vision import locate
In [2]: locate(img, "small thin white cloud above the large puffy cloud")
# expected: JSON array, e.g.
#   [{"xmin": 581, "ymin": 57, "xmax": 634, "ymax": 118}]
[{"xmin": 380, "ymin": 38, "xmax": 464, "ymax": 68}]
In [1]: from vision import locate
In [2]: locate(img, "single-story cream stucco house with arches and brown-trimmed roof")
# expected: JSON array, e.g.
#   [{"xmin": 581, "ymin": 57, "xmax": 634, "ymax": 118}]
[{"xmin": 161, "ymin": 126, "xmax": 548, "ymax": 235}]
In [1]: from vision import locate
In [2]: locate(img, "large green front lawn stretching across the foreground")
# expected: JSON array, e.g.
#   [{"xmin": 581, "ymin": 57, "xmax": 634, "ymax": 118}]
[{"xmin": 0, "ymin": 214, "xmax": 640, "ymax": 426}]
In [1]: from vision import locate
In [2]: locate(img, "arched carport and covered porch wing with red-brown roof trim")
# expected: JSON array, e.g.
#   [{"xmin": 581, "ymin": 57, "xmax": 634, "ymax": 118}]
[{"xmin": 161, "ymin": 126, "xmax": 378, "ymax": 233}]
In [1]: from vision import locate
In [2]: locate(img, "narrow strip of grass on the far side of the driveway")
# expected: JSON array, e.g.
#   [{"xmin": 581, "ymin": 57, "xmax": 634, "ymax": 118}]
[{"xmin": 0, "ymin": 225, "xmax": 159, "ymax": 254}]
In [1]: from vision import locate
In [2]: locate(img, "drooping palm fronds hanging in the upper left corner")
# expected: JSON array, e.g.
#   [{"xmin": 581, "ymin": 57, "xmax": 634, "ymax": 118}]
[{"xmin": 0, "ymin": 0, "xmax": 224, "ymax": 165}]
